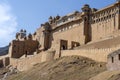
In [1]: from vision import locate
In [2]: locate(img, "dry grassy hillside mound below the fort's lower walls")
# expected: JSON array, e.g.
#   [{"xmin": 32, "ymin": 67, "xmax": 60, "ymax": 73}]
[{"xmin": 7, "ymin": 56, "xmax": 106, "ymax": 80}]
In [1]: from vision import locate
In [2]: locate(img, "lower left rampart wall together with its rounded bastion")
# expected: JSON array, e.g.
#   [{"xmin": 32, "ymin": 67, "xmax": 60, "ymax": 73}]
[{"xmin": 10, "ymin": 51, "xmax": 54, "ymax": 71}]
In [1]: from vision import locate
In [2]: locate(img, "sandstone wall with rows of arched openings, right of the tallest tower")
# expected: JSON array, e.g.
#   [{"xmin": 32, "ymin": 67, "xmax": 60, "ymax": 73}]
[{"xmin": 91, "ymin": 5, "xmax": 120, "ymax": 41}]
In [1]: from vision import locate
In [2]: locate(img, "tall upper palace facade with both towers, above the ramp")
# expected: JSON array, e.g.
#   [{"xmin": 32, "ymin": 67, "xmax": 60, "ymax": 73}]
[{"xmin": 34, "ymin": 1, "xmax": 120, "ymax": 51}]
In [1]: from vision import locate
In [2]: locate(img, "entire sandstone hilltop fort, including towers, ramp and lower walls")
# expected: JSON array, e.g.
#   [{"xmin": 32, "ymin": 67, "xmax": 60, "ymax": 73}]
[{"xmin": 0, "ymin": 0, "xmax": 120, "ymax": 71}]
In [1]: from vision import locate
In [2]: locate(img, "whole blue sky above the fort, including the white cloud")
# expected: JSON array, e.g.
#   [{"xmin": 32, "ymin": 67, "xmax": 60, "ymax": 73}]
[{"xmin": 0, "ymin": 0, "xmax": 116, "ymax": 47}]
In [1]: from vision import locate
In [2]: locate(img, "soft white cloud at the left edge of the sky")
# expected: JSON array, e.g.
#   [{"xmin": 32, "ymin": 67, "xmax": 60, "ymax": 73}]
[{"xmin": 0, "ymin": 3, "xmax": 17, "ymax": 47}]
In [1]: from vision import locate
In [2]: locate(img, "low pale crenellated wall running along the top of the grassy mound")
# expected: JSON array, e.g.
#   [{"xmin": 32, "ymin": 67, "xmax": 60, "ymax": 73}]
[{"xmin": 61, "ymin": 47, "xmax": 119, "ymax": 62}]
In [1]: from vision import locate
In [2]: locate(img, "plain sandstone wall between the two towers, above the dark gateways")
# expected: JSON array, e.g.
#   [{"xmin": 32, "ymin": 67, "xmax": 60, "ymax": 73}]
[{"xmin": 52, "ymin": 22, "xmax": 84, "ymax": 48}]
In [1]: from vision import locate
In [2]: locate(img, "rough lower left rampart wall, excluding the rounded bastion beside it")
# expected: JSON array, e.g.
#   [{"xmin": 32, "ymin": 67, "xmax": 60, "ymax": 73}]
[{"xmin": 10, "ymin": 54, "xmax": 42, "ymax": 71}]
